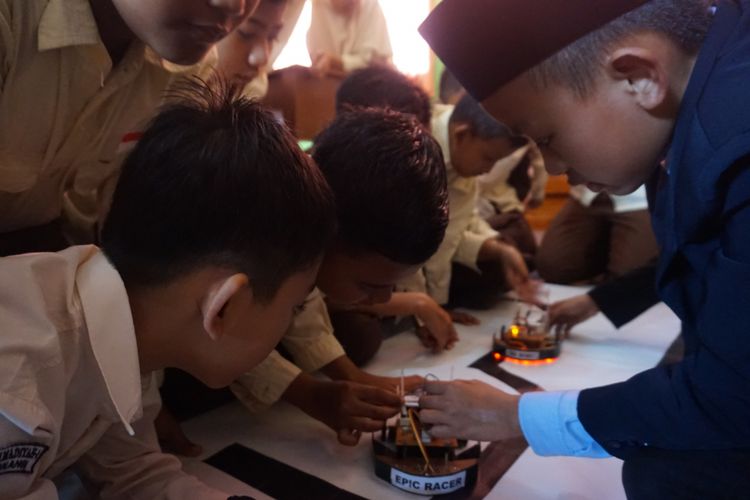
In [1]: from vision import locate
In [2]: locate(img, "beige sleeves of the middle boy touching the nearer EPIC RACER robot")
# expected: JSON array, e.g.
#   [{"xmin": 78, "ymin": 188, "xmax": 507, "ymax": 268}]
[{"xmin": 232, "ymin": 289, "xmax": 345, "ymax": 411}]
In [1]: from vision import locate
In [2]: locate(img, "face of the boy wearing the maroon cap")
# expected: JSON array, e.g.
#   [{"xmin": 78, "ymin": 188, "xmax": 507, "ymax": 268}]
[{"xmin": 482, "ymin": 74, "xmax": 673, "ymax": 194}]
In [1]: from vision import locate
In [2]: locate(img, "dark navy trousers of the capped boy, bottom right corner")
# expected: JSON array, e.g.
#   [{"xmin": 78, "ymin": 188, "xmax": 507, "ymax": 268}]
[{"xmin": 622, "ymin": 449, "xmax": 750, "ymax": 500}]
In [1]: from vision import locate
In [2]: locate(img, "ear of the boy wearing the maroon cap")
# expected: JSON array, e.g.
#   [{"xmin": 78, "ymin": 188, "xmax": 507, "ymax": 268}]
[{"xmin": 606, "ymin": 46, "xmax": 669, "ymax": 111}]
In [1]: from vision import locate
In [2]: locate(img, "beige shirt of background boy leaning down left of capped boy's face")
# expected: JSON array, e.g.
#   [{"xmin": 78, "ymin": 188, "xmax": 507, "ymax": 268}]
[{"xmin": 423, "ymin": 105, "xmax": 498, "ymax": 304}]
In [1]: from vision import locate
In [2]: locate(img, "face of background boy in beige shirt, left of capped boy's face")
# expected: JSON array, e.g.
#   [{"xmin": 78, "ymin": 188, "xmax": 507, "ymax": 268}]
[{"xmin": 450, "ymin": 129, "xmax": 515, "ymax": 177}]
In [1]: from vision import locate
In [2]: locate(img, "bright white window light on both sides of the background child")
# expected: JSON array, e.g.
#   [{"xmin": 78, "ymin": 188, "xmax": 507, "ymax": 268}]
[{"xmin": 274, "ymin": 0, "xmax": 430, "ymax": 75}]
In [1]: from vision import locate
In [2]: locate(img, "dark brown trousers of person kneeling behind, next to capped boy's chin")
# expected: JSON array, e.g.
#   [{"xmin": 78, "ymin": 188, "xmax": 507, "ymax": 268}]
[{"xmin": 536, "ymin": 197, "xmax": 659, "ymax": 285}]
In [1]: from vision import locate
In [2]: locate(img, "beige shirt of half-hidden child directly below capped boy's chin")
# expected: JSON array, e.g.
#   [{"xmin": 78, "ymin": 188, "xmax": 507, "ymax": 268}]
[{"xmin": 477, "ymin": 141, "xmax": 548, "ymax": 219}]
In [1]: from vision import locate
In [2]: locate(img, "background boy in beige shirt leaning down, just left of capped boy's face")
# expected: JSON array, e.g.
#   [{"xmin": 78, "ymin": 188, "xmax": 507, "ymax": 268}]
[{"xmin": 424, "ymin": 95, "xmax": 532, "ymax": 308}]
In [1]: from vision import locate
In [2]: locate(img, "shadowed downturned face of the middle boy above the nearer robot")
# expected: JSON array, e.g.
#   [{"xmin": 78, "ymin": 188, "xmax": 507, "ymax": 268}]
[{"xmin": 316, "ymin": 247, "xmax": 420, "ymax": 306}]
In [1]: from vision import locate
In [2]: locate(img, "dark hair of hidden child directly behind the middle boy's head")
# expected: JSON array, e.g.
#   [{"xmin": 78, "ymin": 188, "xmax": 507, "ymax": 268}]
[{"xmin": 336, "ymin": 64, "xmax": 432, "ymax": 127}]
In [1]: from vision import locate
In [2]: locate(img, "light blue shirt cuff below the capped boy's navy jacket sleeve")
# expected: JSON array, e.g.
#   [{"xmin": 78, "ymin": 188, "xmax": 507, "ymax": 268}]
[{"xmin": 518, "ymin": 391, "xmax": 611, "ymax": 458}]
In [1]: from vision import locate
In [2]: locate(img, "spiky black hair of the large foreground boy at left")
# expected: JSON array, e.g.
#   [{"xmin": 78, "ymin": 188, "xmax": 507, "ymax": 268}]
[{"xmin": 101, "ymin": 76, "xmax": 335, "ymax": 300}]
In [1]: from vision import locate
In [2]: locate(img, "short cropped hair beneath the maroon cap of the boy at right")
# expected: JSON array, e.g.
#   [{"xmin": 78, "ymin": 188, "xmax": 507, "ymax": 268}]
[{"xmin": 529, "ymin": 0, "xmax": 714, "ymax": 98}]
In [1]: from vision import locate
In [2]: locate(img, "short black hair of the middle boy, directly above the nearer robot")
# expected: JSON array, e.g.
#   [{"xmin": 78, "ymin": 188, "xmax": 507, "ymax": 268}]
[{"xmin": 313, "ymin": 108, "xmax": 448, "ymax": 265}]
